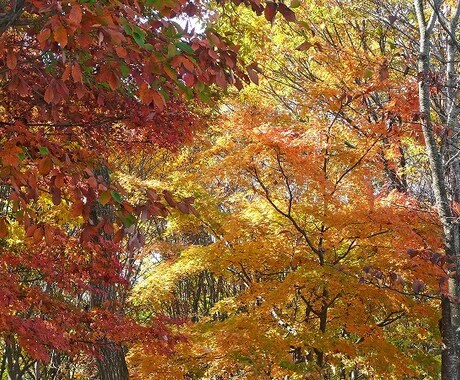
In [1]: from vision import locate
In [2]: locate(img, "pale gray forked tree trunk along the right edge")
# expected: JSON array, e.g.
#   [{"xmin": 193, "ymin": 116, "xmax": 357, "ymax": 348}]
[{"xmin": 414, "ymin": 0, "xmax": 460, "ymax": 380}]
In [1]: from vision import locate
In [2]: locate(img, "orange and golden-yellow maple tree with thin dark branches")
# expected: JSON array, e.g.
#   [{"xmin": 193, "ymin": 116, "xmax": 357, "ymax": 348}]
[{"xmin": 132, "ymin": 4, "xmax": 445, "ymax": 379}]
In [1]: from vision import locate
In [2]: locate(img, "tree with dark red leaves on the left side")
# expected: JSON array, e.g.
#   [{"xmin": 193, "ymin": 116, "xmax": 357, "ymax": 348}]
[{"xmin": 0, "ymin": 1, "xmax": 276, "ymax": 379}]
